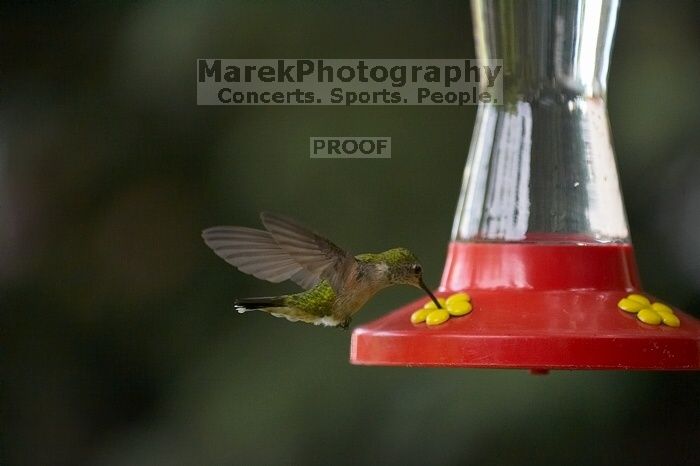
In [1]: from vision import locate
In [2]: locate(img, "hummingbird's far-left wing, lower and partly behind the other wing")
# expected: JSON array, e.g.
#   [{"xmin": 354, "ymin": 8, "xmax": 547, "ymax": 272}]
[{"xmin": 202, "ymin": 226, "xmax": 320, "ymax": 290}]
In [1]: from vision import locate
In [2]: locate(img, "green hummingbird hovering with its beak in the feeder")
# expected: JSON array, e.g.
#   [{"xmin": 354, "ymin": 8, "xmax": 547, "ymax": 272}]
[{"xmin": 202, "ymin": 212, "xmax": 441, "ymax": 329}]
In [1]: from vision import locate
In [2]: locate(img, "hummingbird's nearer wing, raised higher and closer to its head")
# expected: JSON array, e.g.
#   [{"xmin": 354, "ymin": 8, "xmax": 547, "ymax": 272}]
[{"xmin": 260, "ymin": 212, "xmax": 355, "ymax": 291}]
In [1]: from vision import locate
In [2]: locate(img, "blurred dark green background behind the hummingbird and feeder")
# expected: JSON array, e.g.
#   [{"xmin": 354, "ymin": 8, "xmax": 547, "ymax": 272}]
[{"xmin": 0, "ymin": 0, "xmax": 700, "ymax": 466}]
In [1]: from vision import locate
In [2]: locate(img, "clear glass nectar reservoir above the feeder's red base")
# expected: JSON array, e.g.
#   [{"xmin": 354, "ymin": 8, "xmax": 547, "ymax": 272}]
[{"xmin": 452, "ymin": 0, "xmax": 629, "ymax": 244}]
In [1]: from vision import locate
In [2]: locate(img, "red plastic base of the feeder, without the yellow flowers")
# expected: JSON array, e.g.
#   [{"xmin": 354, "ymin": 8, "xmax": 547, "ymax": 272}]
[{"xmin": 350, "ymin": 243, "xmax": 700, "ymax": 373}]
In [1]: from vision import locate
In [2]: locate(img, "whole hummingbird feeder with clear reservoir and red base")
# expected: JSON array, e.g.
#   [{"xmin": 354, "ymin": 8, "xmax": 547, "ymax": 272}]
[{"xmin": 350, "ymin": 0, "xmax": 700, "ymax": 373}]
